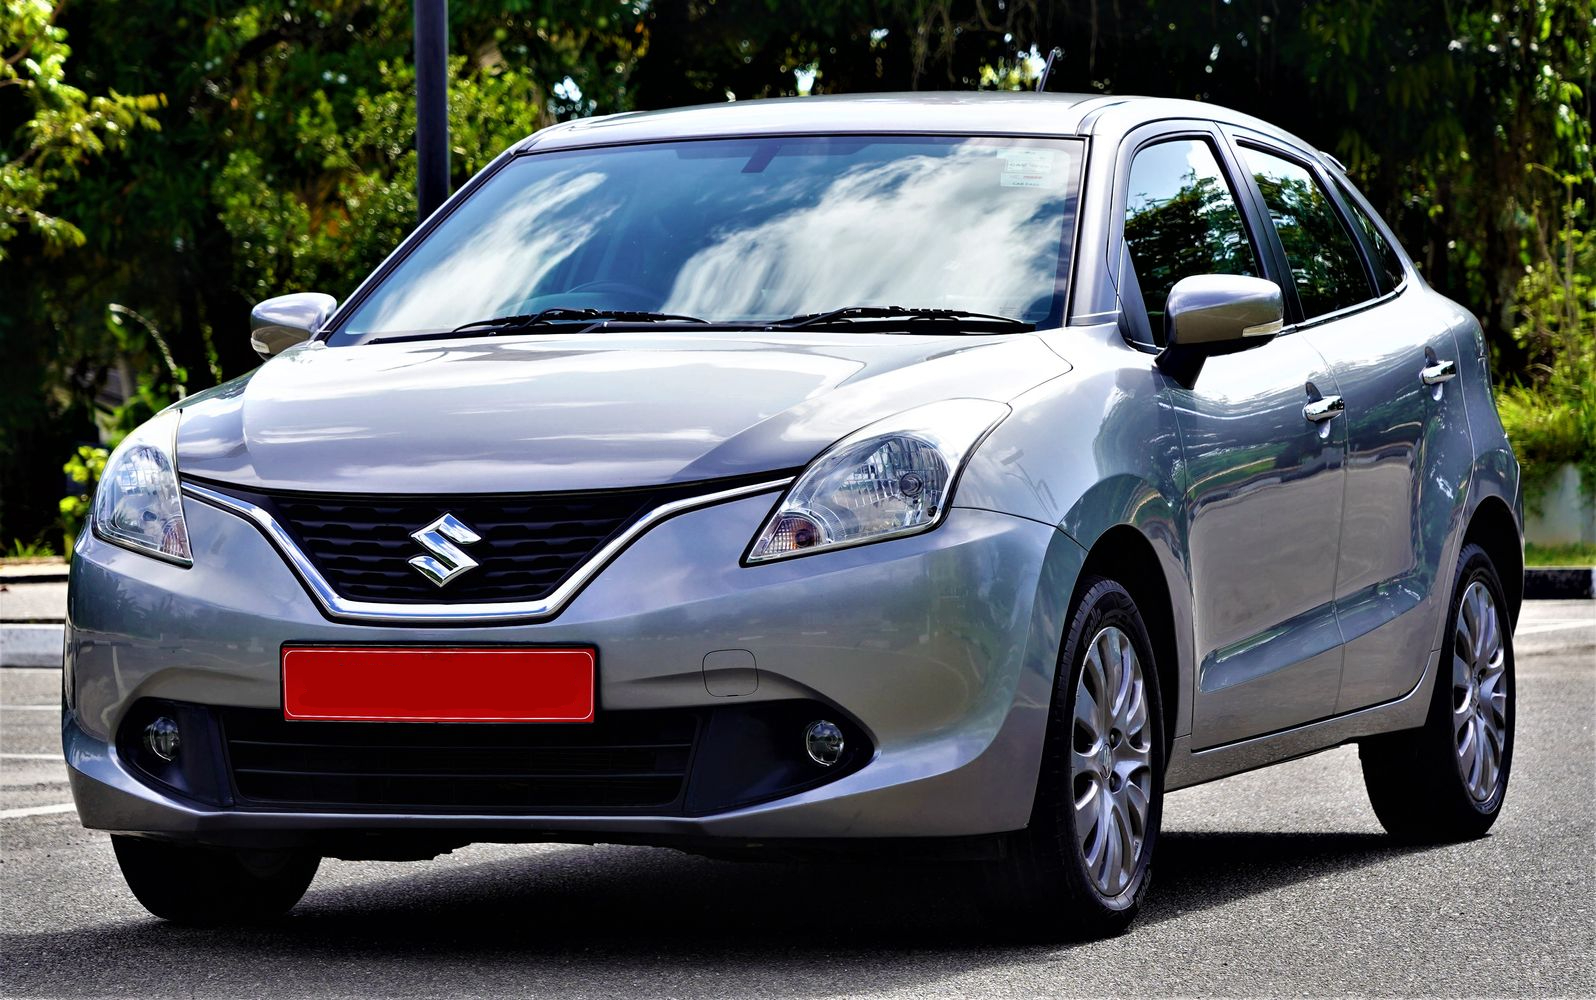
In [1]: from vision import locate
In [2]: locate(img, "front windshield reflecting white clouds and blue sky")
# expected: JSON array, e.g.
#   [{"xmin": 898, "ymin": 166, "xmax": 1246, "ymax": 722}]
[{"xmin": 332, "ymin": 136, "xmax": 1080, "ymax": 343}]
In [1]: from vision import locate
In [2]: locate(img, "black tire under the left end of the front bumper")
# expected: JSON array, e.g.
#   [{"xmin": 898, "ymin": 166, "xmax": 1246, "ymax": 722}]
[{"xmin": 110, "ymin": 834, "xmax": 321, "ymax": 927}]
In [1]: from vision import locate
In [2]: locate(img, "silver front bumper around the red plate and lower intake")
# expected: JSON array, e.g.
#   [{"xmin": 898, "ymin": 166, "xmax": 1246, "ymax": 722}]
[{"xmin": 64, "ymin": 494, "xmax": 1084, "ymax": 842}]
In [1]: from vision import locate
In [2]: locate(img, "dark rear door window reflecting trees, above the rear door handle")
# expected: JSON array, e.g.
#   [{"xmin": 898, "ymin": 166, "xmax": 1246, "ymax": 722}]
[{"xmin": 1242, "ymin": 145, "xmax": 1374, "ymax": 319}]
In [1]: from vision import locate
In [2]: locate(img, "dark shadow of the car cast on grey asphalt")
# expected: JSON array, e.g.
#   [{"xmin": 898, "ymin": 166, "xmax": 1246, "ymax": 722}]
[{"xmin": 0, "ymin": 833, "xmax": 1449, "ymax": 997}]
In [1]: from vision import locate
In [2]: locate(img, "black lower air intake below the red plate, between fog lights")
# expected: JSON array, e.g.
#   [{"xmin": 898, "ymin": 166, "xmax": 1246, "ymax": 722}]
[{"xmin": 220, "ymin": 708, "xmax": 699, "ymax": 813}]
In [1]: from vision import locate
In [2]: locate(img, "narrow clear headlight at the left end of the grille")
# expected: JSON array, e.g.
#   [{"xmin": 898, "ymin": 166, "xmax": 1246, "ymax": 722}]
[{"xmin": 89, "ymin": 410, "xmax": 193, "ymax": 566}]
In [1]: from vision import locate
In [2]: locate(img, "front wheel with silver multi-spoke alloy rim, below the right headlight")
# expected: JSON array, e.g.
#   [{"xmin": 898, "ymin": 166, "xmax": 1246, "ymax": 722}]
[{"xmin": 993, "ymin": 577, "xmax": 1165, "ymax": 938}]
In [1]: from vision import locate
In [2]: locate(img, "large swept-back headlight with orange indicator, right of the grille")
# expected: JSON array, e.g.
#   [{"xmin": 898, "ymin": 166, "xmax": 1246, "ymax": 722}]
[{"xmin": 747, "ymin": 399, "xmax": 1009, "ymax": 563}]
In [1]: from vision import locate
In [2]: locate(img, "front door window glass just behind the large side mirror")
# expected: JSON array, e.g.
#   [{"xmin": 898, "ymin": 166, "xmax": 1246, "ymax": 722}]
[{"xmin": 1125, "ymin": 139, "xmax": 1258, "ymax": 337}]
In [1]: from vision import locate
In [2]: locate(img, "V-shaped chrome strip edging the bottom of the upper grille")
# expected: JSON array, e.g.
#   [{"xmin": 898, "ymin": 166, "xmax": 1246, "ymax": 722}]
[{"xmin": 182, "ymin": 475, "xmax": 793, "ymax": 625}]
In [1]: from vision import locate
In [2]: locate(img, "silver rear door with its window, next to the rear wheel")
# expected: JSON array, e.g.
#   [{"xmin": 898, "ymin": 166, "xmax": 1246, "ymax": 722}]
[{"xmin": 1234, "ymin": 129, "xmax": 1468, "ymax": 713}]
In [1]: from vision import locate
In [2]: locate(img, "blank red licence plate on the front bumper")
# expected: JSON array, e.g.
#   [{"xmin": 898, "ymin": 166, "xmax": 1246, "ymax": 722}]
[{"xmin": 282, "ymin": 646, "xmax": 597, "ymax": 722}]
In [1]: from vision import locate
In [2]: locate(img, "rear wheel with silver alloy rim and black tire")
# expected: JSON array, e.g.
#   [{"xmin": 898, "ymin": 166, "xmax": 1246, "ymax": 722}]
[{"xmin": 1358, "ymin": 545, "xmax": 1513, "ymax": 844}]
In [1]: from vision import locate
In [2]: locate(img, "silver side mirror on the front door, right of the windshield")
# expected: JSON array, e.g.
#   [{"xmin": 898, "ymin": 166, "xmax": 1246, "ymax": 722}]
[{"xmin": 1157, "ymin": 274, "xmax": 1285, "ymax": 389}]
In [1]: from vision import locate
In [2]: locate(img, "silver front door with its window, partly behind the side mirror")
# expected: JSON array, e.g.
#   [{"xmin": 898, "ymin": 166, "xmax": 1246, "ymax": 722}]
[{"xmin": 1117, "ymin": 123, "xmax": 1345, "ymax": 750}]
